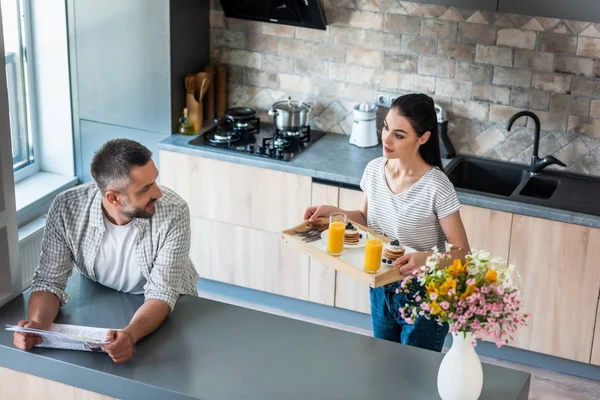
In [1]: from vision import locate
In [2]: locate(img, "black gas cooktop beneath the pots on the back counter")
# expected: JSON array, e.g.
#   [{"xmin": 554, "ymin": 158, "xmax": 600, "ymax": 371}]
[{"xmin": 190, "ymin": 118, "xmax": 325, "ymax": 161}]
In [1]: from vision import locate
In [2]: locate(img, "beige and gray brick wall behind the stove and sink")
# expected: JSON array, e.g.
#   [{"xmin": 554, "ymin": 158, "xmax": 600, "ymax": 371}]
[{"xmin": 211, "ymin": 0, "xmax": 600, "ymax": 175}]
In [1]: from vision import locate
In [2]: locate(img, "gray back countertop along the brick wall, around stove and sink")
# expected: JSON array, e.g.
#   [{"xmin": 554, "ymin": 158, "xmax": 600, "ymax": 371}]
[{"xmin": 159, "ymin": 133, "xmax": 600, "ymax": 228}]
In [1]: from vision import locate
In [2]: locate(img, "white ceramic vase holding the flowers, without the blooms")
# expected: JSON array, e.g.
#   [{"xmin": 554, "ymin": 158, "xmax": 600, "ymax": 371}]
[{"xmin": 438, "ymin": 332, "xmax": 483, "ymax": 400}]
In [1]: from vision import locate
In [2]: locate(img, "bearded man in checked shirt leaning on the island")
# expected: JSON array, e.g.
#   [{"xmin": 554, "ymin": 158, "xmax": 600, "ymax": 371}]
[{"xmin": 14, "ymin": 139, "xmax": 198, "ymax": 363}]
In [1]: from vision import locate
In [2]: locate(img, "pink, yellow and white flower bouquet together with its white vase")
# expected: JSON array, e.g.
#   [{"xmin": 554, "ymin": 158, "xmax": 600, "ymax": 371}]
[{"xmin": 398, "ymin": 245, "xmax": 530, "ymax": 400}]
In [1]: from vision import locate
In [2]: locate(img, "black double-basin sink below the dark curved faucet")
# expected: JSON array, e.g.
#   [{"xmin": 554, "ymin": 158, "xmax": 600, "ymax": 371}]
[{"xmin": 446, "ymin": 156, "xmax": 600, "ymax": 216}]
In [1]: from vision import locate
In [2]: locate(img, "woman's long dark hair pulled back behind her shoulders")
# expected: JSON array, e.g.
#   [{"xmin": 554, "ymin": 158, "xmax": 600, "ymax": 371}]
[{"xmin": 390, "ymin": 94, "xmax": 444, "ymax": 171}]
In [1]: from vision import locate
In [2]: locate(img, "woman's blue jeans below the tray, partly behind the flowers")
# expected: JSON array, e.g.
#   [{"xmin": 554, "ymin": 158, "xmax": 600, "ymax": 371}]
[{"xmin": 370, "ymin": 282, "xmax": 448, "ymax": 352}]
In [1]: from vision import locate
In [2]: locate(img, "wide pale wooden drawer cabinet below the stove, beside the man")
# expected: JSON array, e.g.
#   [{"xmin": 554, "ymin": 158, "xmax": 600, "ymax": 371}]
[{"xmin": 160, "ymin": 151, "xmax": 312, "ymax": 300}]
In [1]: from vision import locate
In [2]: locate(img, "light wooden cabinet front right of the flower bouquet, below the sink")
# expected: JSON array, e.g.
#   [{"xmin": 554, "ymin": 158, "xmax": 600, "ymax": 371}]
[{"xmin": 510, "ymin": 215, "xmax": 600, "ymax": 363}]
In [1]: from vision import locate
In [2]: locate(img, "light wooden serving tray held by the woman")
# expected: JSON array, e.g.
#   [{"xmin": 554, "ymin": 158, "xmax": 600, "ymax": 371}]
[{"xmin": 281, "ymin": 219, "xmax": 415, "ymax": 288}]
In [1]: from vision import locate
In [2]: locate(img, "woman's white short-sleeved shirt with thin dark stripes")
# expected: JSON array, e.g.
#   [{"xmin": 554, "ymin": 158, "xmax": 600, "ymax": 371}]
[{"xmin": 360, "ymin": 157, "xmax": 460, "ymax": 251}]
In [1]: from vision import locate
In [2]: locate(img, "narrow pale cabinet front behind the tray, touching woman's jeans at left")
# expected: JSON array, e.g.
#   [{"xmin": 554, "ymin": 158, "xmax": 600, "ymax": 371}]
[{"xmin": 335, "ymin": 188, "xmax": 371, "ymax": 314}]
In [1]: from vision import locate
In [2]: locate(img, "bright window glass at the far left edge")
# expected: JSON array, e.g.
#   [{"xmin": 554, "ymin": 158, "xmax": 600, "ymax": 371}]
[{"xmin": 0, "ymin": 0, "xmax": 39, "ymax": 182}]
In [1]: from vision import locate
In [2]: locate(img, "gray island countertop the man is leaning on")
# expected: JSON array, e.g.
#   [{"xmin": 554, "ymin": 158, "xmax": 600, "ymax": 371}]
[{"xmin": 0, "ymin": 274, "xmax": 530, "ymax": 400}]
